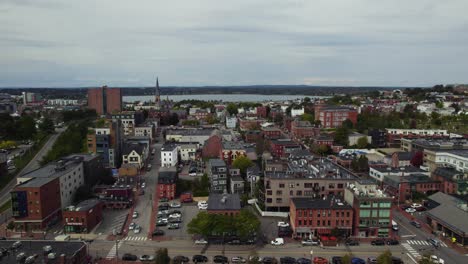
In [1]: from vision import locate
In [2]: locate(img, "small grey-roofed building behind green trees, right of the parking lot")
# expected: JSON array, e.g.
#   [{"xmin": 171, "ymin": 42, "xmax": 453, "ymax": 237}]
[{"xmin": 207, "ymin": 193, "xmax": 241, "ymax": 216}]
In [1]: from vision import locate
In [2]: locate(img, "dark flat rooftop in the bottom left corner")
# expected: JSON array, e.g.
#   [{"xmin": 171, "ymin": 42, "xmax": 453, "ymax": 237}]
[{"xmin": 0, "ymin": 240, "xmax": 86, "ymax": 264}]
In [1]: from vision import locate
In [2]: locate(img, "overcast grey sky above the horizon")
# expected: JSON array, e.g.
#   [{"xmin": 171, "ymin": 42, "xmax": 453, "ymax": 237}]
[{"xmin": 0, "ymin": 0, "xmax": 468, "ymax": 87}]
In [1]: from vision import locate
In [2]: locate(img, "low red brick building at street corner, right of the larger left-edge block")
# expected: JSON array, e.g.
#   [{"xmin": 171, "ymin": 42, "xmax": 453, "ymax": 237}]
[{"xmin": 62, "ymin": 199, "xmax": 103, "ymax": 233}]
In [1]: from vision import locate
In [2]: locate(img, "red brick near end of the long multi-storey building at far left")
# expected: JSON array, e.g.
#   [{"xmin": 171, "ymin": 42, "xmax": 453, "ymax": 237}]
[{"xmin": 10, "ymin": 177, "xmax": 61, "ymax": 233}]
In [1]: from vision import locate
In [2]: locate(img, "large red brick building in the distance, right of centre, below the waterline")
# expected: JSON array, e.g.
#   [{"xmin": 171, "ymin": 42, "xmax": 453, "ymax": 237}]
[{"xmin": 315, "ymin": 104, "xmax": 358, "ymax": 128}]
